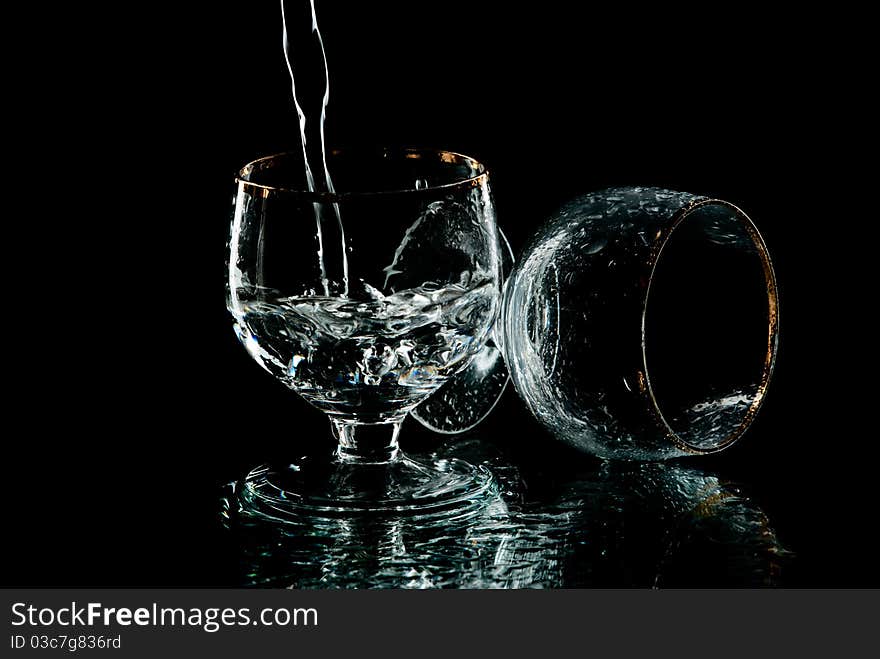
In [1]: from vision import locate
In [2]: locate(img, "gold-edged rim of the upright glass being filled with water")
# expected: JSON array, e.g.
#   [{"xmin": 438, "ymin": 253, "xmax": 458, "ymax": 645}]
[{"xmin": 235, "ymin": 147, "xmax": 489, "ymax": 203}]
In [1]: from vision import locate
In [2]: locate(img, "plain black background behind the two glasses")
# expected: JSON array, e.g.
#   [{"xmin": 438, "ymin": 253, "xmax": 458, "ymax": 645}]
[{"xmin": 3, "ymin": 0, "xmax": 880, "ymax": 587}]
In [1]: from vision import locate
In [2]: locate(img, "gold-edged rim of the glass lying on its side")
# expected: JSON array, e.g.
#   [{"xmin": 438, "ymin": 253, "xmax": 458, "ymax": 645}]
[{"xmin": 641, "ymin": 198, "xmax": 779, "ymax": 455}]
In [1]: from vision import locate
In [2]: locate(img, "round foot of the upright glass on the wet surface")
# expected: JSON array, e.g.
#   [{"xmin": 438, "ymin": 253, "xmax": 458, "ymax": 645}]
[{"xmin": 236, "ymin": 455, "xmax": 495, "ymax": 523}]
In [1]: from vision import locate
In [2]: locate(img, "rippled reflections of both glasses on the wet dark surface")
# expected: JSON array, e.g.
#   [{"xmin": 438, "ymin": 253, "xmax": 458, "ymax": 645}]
[{"xmin": 225, "ymin": 440, "xmax": 789, "ymax": 588}]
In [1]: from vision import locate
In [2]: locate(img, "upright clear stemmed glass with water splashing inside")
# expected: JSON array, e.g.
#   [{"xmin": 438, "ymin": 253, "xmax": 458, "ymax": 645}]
[{"xmin": 227, "ymin": 149, "xmax": 500, "ymax": 519}]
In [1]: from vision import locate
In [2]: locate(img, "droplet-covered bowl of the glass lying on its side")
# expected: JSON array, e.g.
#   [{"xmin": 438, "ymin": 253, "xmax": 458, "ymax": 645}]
[{"xmin": 502, "ymin": 187, "xmax": 779, "ymax": 460}]
